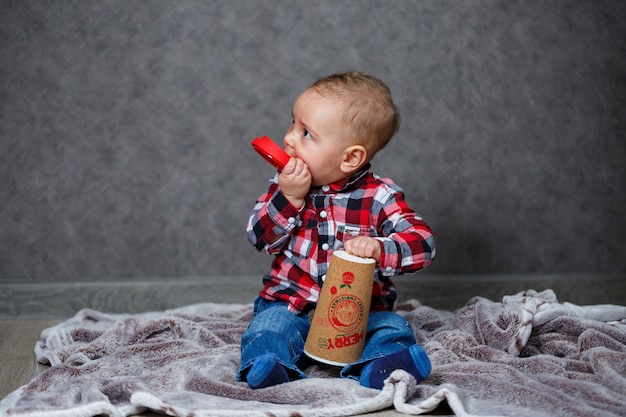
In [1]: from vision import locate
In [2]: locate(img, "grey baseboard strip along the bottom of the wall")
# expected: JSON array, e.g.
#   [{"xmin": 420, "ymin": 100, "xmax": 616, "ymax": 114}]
[{"xmin": 0, "ymin": 274, "xmax": 626, "ymax": 320}]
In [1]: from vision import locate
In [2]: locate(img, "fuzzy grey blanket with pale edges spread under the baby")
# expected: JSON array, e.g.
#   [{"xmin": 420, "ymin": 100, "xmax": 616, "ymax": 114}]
[{"xmin": 0, "ymin": 290, "xmax": 626, "ymax": 417}]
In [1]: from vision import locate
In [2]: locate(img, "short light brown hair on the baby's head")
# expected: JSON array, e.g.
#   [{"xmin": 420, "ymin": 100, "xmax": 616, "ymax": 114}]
[{"xmin": 310, "ymin": 72, "xmax": 400, "ymax": 159}]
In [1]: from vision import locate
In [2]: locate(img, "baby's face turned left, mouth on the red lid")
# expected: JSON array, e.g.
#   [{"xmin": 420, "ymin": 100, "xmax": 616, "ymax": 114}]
[{"xmin": 284, "ymin": 90, "xmax": 348, "ymax": 186}]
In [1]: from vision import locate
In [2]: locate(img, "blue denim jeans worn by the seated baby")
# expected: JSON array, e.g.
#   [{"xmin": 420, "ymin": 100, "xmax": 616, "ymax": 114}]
[{"xmin": 237, "ymin": 297, "xmax": 416, "ymax": 381}]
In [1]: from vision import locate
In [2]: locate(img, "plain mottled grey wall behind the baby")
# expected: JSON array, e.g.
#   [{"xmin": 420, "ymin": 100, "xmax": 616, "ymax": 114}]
[{"xmin": 0, "ymin": 0, "xmax": 626, "ymax": 281}]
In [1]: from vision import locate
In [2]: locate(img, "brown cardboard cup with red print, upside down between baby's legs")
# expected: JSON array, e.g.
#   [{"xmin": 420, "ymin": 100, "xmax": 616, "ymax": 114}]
[{"xmin": 304, "ymin": 251, "xmax": 376, "ymax": 366}]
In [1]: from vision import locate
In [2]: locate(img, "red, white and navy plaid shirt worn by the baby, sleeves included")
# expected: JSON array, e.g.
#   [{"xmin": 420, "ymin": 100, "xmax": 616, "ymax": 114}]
[{"xmin": 246, "ymin": 166, "xmax": 435, "ymax": 313}]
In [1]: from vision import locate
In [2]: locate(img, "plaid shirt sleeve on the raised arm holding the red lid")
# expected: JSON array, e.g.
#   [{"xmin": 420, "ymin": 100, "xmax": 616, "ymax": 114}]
[{"xmin": 246, "ymin": 176, "xmax": 300, "ymax": 255}]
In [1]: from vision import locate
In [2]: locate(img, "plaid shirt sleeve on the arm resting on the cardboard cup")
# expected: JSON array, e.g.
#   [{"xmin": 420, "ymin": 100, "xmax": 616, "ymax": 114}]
[{"xmin": 375, "ymin": 184, "xmax": 435, "ymax": 276}]
